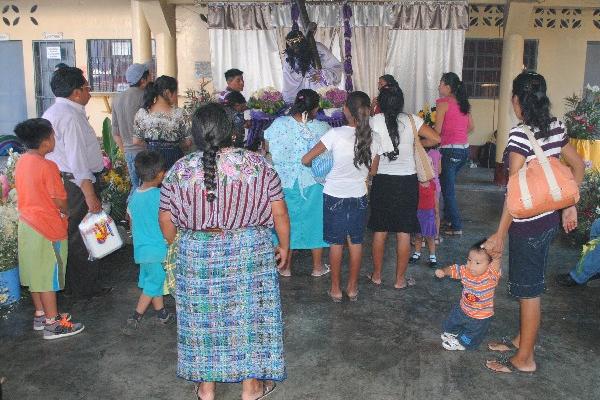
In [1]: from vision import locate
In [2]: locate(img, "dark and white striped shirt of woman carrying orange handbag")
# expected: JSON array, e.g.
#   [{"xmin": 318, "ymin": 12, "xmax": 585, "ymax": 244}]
[{"xmin": 504, "ymin": 118, "xmax": 569, "ymax": 237}]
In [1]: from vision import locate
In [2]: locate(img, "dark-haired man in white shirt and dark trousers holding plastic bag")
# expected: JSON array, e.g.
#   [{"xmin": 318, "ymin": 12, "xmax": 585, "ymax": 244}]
[{"xmin": 43, "ymin": 67, "xmax": 112, "ymax": 297}]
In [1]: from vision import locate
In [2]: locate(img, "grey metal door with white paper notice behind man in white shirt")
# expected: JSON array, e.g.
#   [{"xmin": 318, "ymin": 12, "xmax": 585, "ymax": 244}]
[{"xmin": 33, "ymin": 40, "xmax": 75, "ymax": 116}]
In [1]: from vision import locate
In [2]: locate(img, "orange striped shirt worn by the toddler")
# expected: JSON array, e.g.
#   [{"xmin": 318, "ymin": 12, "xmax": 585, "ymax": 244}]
[{"xmin": 450, "ymin": 261, "xmax": 501, "ymax": 319}]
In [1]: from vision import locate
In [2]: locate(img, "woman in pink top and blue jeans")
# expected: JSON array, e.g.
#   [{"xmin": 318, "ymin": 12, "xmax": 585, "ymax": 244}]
[{"xmin": 435, "ymin": 72, "xmax": 473, "ymax": 235}]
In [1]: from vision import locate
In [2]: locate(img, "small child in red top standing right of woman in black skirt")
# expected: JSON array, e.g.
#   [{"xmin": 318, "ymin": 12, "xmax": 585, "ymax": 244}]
[{"xmin": 409, "ymin": 179, "xmax": 437, "ymax": 268}]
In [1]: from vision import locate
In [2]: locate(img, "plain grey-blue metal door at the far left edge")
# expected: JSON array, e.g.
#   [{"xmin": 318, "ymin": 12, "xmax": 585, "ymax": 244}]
[{"xmin": 0, "ymin": 40, "xmax": 27, "ymax": 135}]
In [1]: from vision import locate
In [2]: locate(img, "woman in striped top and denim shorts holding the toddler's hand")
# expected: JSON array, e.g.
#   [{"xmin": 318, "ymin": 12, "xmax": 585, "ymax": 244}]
[{"xmin": 483, "ymin": 72, "xmax": 584, "ymax": 373}]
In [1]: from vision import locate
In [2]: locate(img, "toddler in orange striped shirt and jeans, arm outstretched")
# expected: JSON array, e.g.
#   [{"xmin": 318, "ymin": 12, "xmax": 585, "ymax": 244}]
[{"xmin": 435, "ymin": 239, "xmax": 501, "ymax": 350}]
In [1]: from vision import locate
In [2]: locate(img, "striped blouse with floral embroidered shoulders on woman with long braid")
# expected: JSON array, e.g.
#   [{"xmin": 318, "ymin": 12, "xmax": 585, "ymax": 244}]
[{"xmin": 160, "ymin": 148, "xmax": 283, "ymax": 230}]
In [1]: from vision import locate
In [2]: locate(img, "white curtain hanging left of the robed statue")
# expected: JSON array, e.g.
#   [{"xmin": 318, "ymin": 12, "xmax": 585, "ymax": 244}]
[{"xmin": 208, "ymin": 29, "xmax": 282, "ymax": 98}]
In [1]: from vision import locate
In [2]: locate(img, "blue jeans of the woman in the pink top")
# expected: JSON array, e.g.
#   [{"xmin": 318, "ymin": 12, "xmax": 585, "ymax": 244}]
[{"xmin": 440, "ymin": 148, "xmax": 469, "ymax": 231}]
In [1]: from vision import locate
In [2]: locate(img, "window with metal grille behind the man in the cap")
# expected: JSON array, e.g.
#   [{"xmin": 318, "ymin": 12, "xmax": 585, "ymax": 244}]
[{"xmin": 87, "ymin": 39, "xmax": 133, "ymax": 92}]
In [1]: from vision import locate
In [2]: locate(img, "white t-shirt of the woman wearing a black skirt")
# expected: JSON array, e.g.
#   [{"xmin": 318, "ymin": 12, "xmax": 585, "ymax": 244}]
[{"xmin": 371, "ymin": 114, "xmax": 425, "ymax": 175}]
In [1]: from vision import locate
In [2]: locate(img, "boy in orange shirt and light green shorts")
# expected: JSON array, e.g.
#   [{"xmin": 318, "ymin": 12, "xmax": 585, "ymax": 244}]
[{"xmin": 15, "ymin": 118, "xmax": 84, "ymax": 339}]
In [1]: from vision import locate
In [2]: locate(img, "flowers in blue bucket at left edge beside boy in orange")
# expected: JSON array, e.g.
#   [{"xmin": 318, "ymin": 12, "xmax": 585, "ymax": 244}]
[{"xmin": 0, "ymin": 151, "xmax": 21, "ymax": 307}]
